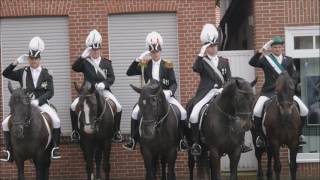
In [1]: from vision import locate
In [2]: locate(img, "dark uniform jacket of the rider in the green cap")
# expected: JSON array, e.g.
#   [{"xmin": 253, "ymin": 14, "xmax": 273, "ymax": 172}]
[{"xmin": 249, "ymin": 53, "xmax": 294, "ymax": 97}]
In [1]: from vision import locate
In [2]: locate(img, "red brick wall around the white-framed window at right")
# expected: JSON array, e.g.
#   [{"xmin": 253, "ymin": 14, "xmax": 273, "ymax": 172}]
[{"xmin": 254, "ymin": 0, "xmax": 320, "ymax": 177}]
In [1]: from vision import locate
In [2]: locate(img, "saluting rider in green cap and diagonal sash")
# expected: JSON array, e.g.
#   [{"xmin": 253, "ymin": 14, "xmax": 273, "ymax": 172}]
[{"xmin": 249, "ymin": 36, "xmax": 309, "ymax": 147}]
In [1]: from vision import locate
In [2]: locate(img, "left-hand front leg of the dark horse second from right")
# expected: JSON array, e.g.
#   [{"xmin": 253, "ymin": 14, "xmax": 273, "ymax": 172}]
[{"xmin": 209, "ymin": 148, "xmax": 221, "ymax": 180}]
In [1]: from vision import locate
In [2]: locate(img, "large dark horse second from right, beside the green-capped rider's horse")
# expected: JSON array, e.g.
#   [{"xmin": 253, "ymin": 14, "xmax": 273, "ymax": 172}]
[{"xmin": 189, "ymin": 77, "xmax": 256, "ymax": 180}]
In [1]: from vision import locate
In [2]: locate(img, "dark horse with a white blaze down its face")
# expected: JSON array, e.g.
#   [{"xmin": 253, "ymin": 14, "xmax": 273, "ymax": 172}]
[{"xmin": 75, "ymin": 82, "xmax": 114, "ymax": 180}]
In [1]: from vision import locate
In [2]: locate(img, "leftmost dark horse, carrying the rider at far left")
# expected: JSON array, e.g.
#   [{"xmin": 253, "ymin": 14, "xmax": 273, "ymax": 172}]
[{"xmin": 8, "ymin": 82, "xmax": 53, "ymax": 180}]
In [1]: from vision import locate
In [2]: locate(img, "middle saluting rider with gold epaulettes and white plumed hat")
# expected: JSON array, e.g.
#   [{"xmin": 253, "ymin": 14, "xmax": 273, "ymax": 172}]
[{"xmin": 123, "ymin": 31, "xmax": 188, "ymax": 150}]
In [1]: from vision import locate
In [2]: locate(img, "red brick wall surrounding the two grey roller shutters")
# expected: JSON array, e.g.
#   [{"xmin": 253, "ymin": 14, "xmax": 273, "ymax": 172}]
[{"xmin": 0, "ymin": 0, "xmax": 215, "ymax": 180}]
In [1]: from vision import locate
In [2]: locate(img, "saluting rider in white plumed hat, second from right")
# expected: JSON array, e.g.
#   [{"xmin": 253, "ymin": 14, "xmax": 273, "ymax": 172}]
[{"xmin": 188, "ymin": 24, "xmax": 252, "ymax": 155}]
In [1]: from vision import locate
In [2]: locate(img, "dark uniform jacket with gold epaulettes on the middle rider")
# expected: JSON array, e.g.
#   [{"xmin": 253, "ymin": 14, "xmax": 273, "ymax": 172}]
[{"xmin": 127, "ymin": 60, "xmax": 177, "ymax": 95}]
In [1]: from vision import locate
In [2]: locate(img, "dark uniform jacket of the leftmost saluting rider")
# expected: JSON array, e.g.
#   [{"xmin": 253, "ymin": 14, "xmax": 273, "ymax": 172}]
[{"xmin": 2, "ymin": 64, "xmax": 54, "ymax": 106}]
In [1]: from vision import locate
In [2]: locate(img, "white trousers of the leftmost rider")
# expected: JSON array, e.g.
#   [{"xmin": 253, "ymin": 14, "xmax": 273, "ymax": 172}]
[{"xmin": 2, "ymin": 104, "xmax": 60, "ymax": 131}]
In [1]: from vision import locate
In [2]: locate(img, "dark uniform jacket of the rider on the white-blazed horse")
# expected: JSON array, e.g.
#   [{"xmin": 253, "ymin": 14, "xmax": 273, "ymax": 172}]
[{"xmin": 72, "ymin": 57, "xmax": 115, "ymax": 90}]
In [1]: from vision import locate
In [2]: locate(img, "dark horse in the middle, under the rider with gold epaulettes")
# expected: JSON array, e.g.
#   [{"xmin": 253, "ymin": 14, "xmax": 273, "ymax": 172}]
[{"xmin": 131, "ymin": 80, "xmax": 178, "ymax": 180}]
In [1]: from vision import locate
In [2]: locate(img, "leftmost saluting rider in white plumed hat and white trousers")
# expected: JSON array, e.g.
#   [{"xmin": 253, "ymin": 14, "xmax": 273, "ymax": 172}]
[{"xmin": 0, "ymin": 37, "xmax": 61, "ymax": 161}]
